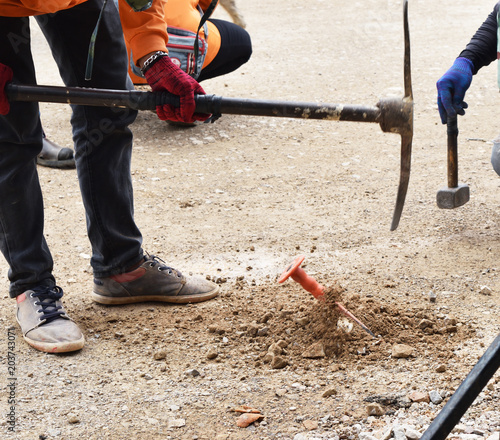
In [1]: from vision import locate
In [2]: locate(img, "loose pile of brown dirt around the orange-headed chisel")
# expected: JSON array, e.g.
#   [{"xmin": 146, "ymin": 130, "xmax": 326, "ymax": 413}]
[{"xmin": 242, "ymin": 282, "xmax": 474, "ymax": 363}]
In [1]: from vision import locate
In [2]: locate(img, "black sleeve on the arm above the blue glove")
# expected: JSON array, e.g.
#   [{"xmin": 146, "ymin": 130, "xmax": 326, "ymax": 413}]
[{"xmin": 459, "ymin": 2, "xmax": 500, "ymax": 74}]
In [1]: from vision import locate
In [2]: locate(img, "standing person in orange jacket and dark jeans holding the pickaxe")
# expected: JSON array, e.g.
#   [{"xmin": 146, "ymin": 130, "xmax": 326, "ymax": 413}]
[{"xmin": 0, "ymin": 0, "xmax": 218, "ymax": 353}]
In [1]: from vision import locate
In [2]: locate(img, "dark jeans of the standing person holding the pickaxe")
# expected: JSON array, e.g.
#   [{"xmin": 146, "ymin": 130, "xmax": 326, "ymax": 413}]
[{"xmin": 0, "ymin": 0, "xmax": 143, "ymax": 297}]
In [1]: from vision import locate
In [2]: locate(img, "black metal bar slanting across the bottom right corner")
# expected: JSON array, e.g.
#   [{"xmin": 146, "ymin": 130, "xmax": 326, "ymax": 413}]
[{"xmin": 420, "ymin": 335, "xmax": 500, "ymax": 440}]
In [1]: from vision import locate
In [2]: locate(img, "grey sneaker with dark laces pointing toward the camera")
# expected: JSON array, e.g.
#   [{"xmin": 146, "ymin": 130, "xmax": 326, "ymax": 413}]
[{"xmin": 16, "ymin": 286, "xmax": 85, "ymax": 353}]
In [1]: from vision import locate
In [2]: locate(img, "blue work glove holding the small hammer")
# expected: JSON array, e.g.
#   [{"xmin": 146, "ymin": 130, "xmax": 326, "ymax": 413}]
[{"xmin": 436, "ymin": 57, "xmax": 474, "ymax": 124}]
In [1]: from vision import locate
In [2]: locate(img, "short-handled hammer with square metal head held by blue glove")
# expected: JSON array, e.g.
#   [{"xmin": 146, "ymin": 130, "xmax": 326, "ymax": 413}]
[{"xmin": 436, "ymin": 116, "xmax": 470, "ymax": 209}]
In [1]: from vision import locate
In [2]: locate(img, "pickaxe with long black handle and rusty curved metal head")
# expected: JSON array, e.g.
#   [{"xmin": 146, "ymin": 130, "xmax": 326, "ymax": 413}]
[{"xmin": 5, "ymin": 0, "xmax": 413, "ymax": 231}]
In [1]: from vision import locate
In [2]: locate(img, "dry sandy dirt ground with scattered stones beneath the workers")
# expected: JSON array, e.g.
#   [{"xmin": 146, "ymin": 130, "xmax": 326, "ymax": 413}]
[{"xmin": 0, "ymin": 0, "xmax": 500, "ymax": 440}]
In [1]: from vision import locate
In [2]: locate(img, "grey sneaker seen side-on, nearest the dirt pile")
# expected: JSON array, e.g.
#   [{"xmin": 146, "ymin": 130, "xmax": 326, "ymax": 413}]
[{"xmin": 92, "ymin": 254, "xmax": 219, "ymax": 305}]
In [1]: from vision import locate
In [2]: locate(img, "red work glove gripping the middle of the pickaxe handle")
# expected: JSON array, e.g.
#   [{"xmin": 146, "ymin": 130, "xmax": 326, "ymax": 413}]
[{"xmin": 144, "ymin": 55, "xmax": 210, "ymax": 123}]
